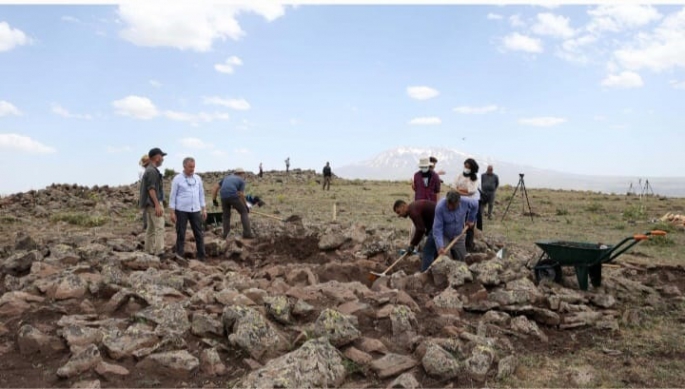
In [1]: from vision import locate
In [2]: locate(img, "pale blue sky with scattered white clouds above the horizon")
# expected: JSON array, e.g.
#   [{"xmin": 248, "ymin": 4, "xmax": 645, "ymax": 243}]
[{"xmin": 0, "ymin": 1, "xmax": 685, "ymax": 194}]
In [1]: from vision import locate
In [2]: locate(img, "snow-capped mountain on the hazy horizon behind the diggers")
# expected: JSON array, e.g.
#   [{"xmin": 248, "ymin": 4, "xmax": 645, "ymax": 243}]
[{"xmin": 334, "ymin": 147, "xmax": 685, "ymax": 197}]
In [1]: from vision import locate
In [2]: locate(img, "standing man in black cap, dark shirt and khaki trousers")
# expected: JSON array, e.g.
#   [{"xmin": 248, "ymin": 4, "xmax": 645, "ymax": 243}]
[{"xmin": 139, "ymin": 147, "xmax": 166, "ymax": 257}]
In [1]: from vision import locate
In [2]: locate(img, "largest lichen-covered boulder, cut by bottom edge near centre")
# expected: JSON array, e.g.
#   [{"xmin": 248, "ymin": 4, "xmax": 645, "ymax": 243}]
[{"xmin": 237, "ymin": 338, "xmax": 346, "ymax": 389}]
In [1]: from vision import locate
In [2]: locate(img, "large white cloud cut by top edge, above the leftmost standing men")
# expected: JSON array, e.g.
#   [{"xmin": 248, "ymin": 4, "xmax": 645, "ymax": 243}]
[{"xmin": 118, "ymin": 0, "xmax": 285, "ymax": 52}]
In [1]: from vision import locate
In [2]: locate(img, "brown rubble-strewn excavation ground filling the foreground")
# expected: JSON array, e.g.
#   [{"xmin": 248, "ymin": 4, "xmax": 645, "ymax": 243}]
[{"xmin": 0, "ymin": 174, "xmax": 685, "ymax": 389}]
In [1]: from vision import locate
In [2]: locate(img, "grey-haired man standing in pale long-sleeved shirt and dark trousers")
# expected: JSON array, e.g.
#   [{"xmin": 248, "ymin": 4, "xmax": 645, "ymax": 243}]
[{"xmin": 169, "ymin": 157, "xmax": 207, "ymax": 261}]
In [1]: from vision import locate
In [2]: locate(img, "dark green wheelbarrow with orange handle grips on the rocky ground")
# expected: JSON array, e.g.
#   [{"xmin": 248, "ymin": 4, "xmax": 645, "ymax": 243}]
[{"xmin": 533, "ymin": 230, "xmax": 666, "ymax": 290}]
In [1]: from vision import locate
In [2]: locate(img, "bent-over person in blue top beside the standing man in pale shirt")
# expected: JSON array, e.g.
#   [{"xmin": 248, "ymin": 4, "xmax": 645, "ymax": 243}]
[{"xmin": 212, "ymin": 168, "xmax": 254, "ymax": 239}]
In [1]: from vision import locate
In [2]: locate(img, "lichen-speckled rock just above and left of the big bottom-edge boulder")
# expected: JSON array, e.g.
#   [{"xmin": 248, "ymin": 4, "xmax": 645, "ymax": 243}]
[{"xmin": 221, "ymin": 305, "xmax": 286, "ymax": 360}]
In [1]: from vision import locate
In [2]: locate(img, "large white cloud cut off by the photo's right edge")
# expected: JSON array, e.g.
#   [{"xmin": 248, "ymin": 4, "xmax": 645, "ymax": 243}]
[{"xmin": 614, "ymin": 8, "xmax": 685, "ymax": 72}]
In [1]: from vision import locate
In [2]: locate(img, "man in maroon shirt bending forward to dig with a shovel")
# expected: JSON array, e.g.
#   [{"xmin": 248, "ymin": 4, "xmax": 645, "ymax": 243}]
[{"xmin": 392, "ymin": 200, "xmax": 437, "ymax": 271}]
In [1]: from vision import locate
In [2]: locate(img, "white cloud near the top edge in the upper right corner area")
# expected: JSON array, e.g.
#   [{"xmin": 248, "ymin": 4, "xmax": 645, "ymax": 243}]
[{"xmin": 588, "ymin": 4, "xmax": 662, "ymax": 33}]
